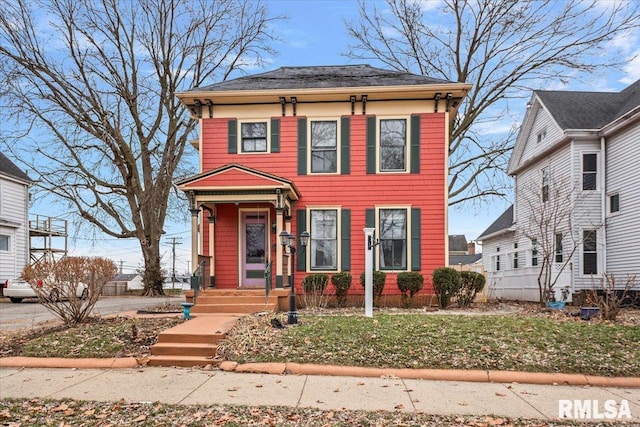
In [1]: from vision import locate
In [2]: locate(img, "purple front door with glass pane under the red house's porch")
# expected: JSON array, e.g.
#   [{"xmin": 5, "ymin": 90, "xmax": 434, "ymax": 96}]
[{"xmin": 240, "ymin": 212, "xmax": 269, "ymax": 288}]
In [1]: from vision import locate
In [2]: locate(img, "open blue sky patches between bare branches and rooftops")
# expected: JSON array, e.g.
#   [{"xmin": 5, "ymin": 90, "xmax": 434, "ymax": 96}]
[{"xmin": 23, "ymin": 0, "xmax": 640, "ymax": 273}]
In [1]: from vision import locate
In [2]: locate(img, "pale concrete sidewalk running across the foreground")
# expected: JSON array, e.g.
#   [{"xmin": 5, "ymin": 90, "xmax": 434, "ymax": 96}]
[{"xmin": 0, "ymin": 367, "xmax": 640, "ymax": 424}]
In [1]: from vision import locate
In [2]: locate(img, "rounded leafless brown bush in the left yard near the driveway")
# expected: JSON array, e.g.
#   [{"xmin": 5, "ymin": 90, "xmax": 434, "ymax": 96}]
[{"xmin": 22, "ymin": 257, "xmax": 117, "ymax": 325}]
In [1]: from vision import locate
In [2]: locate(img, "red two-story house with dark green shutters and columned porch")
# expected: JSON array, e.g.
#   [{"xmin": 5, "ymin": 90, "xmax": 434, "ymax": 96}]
[{"xmin": 177, "ymin": 65, "xmax": 470, "ymax": 300}]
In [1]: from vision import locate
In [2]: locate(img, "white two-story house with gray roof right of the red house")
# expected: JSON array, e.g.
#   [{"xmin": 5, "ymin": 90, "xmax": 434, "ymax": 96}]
[{"xmin": 478, "ymin": 80, "xmax": 640, "ymax": 301}]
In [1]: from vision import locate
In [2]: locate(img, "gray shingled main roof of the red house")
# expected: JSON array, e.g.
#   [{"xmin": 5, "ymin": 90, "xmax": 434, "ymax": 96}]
[{"xmin": 190, "ymin": 65, "xmax": 455, "ymax": 92}]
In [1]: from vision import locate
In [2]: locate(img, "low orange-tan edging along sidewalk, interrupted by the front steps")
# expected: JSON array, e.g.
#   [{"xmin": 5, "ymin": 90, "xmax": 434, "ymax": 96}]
[{"xmin": 0, "ymin": 357, "xmax": 640, "ymax": 388}]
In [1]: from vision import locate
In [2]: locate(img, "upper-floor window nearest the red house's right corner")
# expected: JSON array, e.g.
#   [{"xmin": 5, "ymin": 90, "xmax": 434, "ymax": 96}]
[{"xmin": 380, "ymin": 119, "xmax": 407, "ymax": 172}]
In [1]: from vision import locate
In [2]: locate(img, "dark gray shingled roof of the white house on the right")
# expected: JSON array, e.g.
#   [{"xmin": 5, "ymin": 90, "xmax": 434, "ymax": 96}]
[{"xmin": 534, "ymin": 80, "xmax": 640, "ymax": 129}]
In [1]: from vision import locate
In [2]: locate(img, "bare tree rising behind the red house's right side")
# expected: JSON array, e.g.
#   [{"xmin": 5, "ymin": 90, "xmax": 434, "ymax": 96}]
[{"xmin": 346, "ymin": 0, "xmax": 640, "ymax": 205}]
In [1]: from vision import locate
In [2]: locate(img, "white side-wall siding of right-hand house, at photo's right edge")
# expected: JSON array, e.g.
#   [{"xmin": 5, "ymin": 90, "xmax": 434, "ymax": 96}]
[{"xmin": 606, "ymin": 123, "xmax": 640, "ymax": 281}]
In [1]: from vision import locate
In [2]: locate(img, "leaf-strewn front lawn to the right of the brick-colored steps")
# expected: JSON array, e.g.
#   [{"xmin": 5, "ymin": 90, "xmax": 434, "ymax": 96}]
[{"xmin": 219, "ymin": 314, "xmax": 640, "ymax": 376}]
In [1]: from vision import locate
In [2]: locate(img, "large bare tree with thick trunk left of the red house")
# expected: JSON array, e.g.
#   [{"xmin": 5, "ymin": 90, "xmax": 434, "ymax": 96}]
[{"xmin": 0, "ymin": 0, "xmax": 281, "ymax": 295}]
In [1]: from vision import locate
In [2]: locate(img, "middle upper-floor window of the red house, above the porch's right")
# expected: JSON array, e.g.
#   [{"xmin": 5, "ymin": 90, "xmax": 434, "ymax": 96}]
[{"xmin": 311, "ymin": 120, "xmax": 338, "ymax": 173}]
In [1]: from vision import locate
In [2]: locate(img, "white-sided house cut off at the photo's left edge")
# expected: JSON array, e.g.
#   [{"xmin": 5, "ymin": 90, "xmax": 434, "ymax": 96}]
[{"xmin": 0, "ymin": 153, "xmax": 32, "ymax": 283}]
